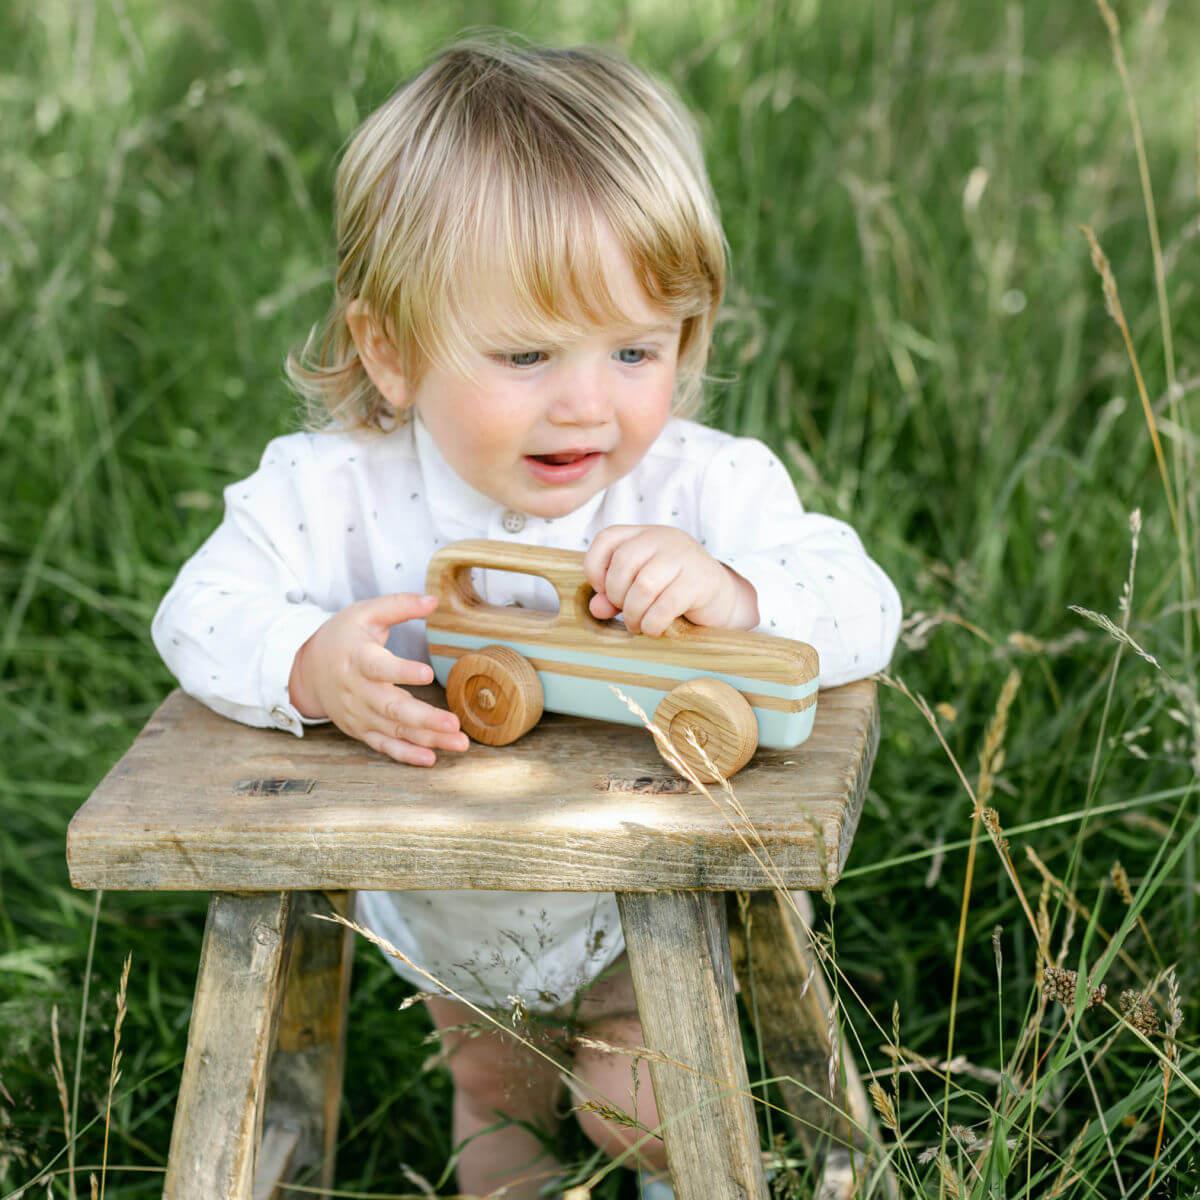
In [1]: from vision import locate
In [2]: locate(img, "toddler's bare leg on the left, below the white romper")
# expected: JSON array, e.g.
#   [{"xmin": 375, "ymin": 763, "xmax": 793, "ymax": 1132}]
[{"xmin": 425, "ymin": 997, "xmax": 563, "ymax": 1200}]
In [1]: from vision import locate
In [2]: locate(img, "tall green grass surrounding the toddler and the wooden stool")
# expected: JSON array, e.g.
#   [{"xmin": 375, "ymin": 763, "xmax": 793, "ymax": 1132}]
[{"xmin": 0, "ymin": 0, "xmax": 1200, "ymax": 1200}]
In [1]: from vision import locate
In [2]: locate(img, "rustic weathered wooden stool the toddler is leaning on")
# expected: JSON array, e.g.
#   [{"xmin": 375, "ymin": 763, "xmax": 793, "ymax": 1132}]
[{"xmin": 67, "ymin": 680, "xmax": 878, "ymax": 1200}]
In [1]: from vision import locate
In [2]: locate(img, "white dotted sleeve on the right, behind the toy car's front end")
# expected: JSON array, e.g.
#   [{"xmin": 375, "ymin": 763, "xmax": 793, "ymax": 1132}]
[{"xmin": 698, "ymin": 438, "xmax": 901, "ymax": 688}]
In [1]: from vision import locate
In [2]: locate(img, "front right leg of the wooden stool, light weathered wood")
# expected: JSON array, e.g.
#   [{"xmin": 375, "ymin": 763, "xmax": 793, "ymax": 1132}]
[{"xmin": 617, "ymin": 892, "xmax": 767, "ymax": 1200}]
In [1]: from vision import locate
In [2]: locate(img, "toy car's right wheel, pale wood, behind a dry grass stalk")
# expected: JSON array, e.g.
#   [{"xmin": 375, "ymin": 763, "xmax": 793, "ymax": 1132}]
[{"xmin": 654, "ymin": 678, "xmax": 758, "ymax": 784}]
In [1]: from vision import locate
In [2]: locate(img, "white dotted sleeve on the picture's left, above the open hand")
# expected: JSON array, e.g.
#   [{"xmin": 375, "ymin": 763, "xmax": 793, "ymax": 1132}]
[{"xmin": 151, "ymin": 434, "xmax": 332, "ymax": 737}]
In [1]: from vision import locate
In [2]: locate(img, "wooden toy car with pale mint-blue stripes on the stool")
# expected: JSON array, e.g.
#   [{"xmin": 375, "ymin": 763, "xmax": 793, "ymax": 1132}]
[{"xmin": 425, "ymin": 539, "xmax": 818, "ymax": 782}]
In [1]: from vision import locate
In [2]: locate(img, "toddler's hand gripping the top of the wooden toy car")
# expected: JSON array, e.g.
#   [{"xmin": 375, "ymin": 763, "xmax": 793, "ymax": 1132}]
[{"xmin": 583, "ymin": 526, "xmax": 758, "ymax": 637}]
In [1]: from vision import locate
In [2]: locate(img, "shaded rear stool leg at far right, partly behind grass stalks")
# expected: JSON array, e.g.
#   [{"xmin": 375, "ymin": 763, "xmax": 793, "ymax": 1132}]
[{"xmin": 730, "ymin": 892, "xmax": 882, "ymax": 1196}]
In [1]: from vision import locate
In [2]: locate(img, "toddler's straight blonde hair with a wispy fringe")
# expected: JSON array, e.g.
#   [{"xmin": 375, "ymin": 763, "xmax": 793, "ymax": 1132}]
[{"xmin": 284, "ymin": 37, "xmax": 726, "ymax": 430}]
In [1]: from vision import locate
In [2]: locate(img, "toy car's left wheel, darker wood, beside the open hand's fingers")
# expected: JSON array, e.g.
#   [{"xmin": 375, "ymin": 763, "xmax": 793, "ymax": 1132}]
[{"xmin": 446, "ymin": 646, "xmax": 542, "ymax": 746}]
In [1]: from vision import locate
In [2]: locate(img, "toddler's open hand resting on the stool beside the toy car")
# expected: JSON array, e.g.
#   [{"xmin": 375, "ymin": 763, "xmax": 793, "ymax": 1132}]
[{"xmin": 288, "ymin": 592, "xmax": 470, "ymax": 767}]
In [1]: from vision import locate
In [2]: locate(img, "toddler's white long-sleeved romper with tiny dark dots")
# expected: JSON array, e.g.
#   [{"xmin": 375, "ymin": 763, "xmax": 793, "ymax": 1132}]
[{"xmin": 151, "ymin": 416, "xmax": 901, "ymax": 1012}]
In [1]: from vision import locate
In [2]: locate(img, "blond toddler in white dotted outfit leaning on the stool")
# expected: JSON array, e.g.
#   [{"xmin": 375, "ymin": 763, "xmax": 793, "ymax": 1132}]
[{"xmin": 152, "ymin": 38, "xmax": 900, "ymax": 1200}]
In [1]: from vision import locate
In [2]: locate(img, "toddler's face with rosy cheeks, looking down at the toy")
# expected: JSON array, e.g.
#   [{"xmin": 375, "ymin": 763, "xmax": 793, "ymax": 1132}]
[{"xmin": 410, "ymin": 226, "xmax": 680, "ymax": 517}]
